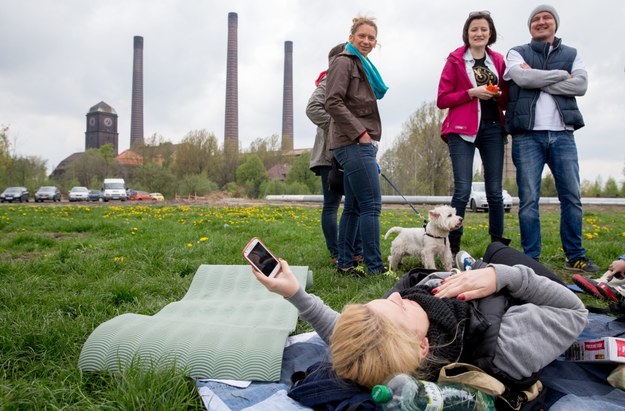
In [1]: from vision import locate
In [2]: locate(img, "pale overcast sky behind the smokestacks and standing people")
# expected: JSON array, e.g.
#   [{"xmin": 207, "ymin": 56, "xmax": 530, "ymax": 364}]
[{"xmin": 0, "ymin": 0, "xmax": 625, "ymax": 182}]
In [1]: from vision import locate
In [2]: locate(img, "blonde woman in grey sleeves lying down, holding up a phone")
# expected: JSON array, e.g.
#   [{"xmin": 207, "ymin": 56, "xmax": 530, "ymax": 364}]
[{"xmin": 254, "ymin": 243, "xmax": 588, "ymax": 389}]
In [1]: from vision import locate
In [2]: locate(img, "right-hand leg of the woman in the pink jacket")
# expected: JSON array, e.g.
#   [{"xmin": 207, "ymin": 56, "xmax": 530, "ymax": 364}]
[{"xmin": 475, "ymin": 123, "xmax": 504, "ymax": 240}]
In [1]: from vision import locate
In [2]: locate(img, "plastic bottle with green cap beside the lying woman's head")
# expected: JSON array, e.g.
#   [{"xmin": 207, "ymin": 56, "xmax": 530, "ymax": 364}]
[{"xmin": 371, "ymin": 374, "xmax": 495, "ymax": 411}]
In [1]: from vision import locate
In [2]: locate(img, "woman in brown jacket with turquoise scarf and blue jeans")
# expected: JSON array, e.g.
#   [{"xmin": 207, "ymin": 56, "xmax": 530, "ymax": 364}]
[{"xmin": 325, "ymin": 17, "xmax": 388, "ymax": 274}]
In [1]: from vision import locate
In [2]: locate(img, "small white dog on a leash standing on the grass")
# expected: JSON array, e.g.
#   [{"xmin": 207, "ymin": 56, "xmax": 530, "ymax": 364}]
[{"xmin": 384, "ymin": 206, "xmax": 462, "ymax": 271}]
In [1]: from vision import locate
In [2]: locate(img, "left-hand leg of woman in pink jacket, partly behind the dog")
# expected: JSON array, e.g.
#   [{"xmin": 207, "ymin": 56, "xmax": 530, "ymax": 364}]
[{"xmin": 447, "ymin": 134, "xmax": 475, "ymax": 255}]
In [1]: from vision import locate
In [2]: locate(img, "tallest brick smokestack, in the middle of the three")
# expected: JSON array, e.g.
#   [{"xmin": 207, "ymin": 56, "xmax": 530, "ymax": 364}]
[{"xmin": 224, "ymin": 13, "xmax": 239, "ymax": 160}]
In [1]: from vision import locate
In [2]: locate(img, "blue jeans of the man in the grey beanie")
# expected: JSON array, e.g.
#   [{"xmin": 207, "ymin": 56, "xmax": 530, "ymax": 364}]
[{"xmin": 512, "ymin": 131, "xmax": 586, "ymax": 261}]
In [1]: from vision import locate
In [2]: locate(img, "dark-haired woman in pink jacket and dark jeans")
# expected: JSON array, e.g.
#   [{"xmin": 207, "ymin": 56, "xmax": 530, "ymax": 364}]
[{"xmin": 436, "ymin": 11, "xmax": 509, "ymax": 255}]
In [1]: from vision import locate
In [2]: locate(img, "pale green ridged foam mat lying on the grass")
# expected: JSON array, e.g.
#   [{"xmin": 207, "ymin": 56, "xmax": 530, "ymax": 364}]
[{"xmin": 78, "ymin": 265, "xmax": 312, "ymax": 381}]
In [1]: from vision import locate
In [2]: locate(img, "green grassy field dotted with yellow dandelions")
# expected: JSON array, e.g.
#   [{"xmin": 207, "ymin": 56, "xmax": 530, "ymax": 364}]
[{"xmin": 0, "ymin": 204, "xmax": 625, "ymax": 410}]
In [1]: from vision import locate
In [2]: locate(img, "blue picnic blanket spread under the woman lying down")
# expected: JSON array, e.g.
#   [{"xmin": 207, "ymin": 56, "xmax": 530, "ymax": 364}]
[{"xmin": 196, "ymin": 313, "xmax": 625, "ymax": 411}]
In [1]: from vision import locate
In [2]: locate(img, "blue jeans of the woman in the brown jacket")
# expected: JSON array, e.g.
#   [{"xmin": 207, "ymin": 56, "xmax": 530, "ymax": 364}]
[{"xmin": 333, "ymin": 143, "xmax": 384, "ymax": 273}]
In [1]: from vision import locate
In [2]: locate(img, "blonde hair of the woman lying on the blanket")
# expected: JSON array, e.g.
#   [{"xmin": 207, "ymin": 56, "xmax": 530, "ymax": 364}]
[{"xmin": 330, "ymin": 304, "xmax": 422, "ymax": 389}]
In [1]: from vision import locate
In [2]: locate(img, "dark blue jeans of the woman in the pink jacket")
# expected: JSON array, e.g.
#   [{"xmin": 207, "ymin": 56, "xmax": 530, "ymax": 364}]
[{"xmin": 447, "ymin": 122, "xmax": 504, "ymax": 245}]
